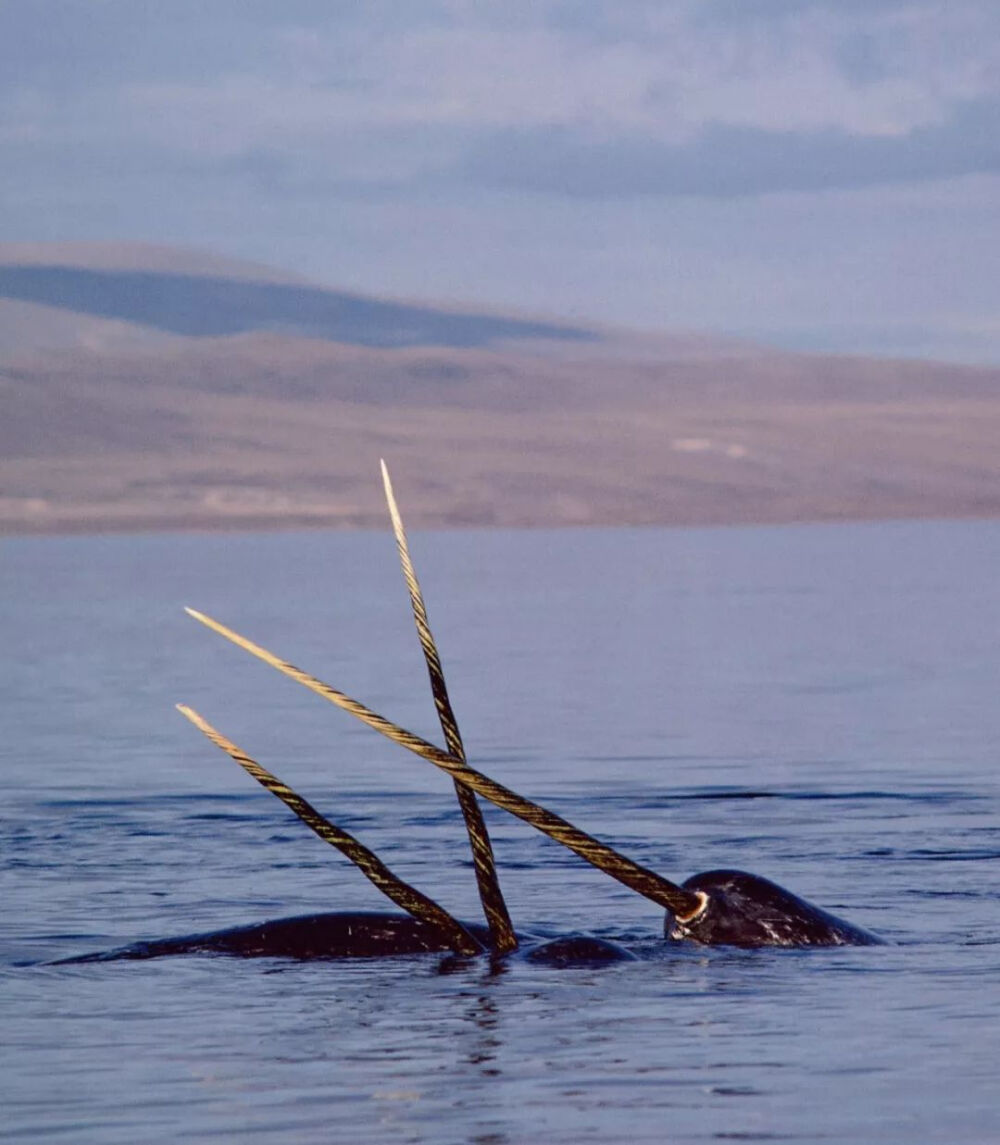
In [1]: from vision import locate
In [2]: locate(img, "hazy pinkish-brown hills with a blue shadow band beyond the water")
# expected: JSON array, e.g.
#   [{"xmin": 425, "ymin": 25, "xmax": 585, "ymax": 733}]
[{"xmin": 0, "ymin": 244, "xmax": 1000, "ymax": 532}]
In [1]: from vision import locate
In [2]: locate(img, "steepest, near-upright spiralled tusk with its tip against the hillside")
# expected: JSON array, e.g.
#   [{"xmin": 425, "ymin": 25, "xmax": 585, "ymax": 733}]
[{"xmin": 379, "ymin": 460, "xmax": 518, "ymax": 954}]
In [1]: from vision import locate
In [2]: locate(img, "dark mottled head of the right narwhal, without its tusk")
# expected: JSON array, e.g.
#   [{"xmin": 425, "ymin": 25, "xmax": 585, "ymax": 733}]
[{"xmin": 663, "ymin": 870, "xmax": 882, "ymax": 947}]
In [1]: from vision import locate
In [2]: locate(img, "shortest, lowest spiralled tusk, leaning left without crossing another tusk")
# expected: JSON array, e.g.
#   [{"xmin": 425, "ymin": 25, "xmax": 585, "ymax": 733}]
[{"xmin": 176, "ymin": 704, "xmax": 482, "ymax": 955}]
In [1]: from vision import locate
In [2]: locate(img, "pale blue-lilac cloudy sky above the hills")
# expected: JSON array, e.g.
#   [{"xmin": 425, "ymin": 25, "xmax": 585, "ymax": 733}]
[{"xmin": 0, "ymin": 0, "xmax": 1000, "ymax": 363}]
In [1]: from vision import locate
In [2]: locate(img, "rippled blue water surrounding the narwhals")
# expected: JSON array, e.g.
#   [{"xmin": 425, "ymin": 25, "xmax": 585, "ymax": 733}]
[{"xmin": 0, "ymin": 523, "xmax": 1000, "ymax": 1145}]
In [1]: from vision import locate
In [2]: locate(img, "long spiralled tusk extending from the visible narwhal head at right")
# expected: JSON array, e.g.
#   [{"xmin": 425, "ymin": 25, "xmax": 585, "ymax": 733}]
[{"xmin": 186, "ymin": 608, "xmax": 702, "ymax": 917}]
